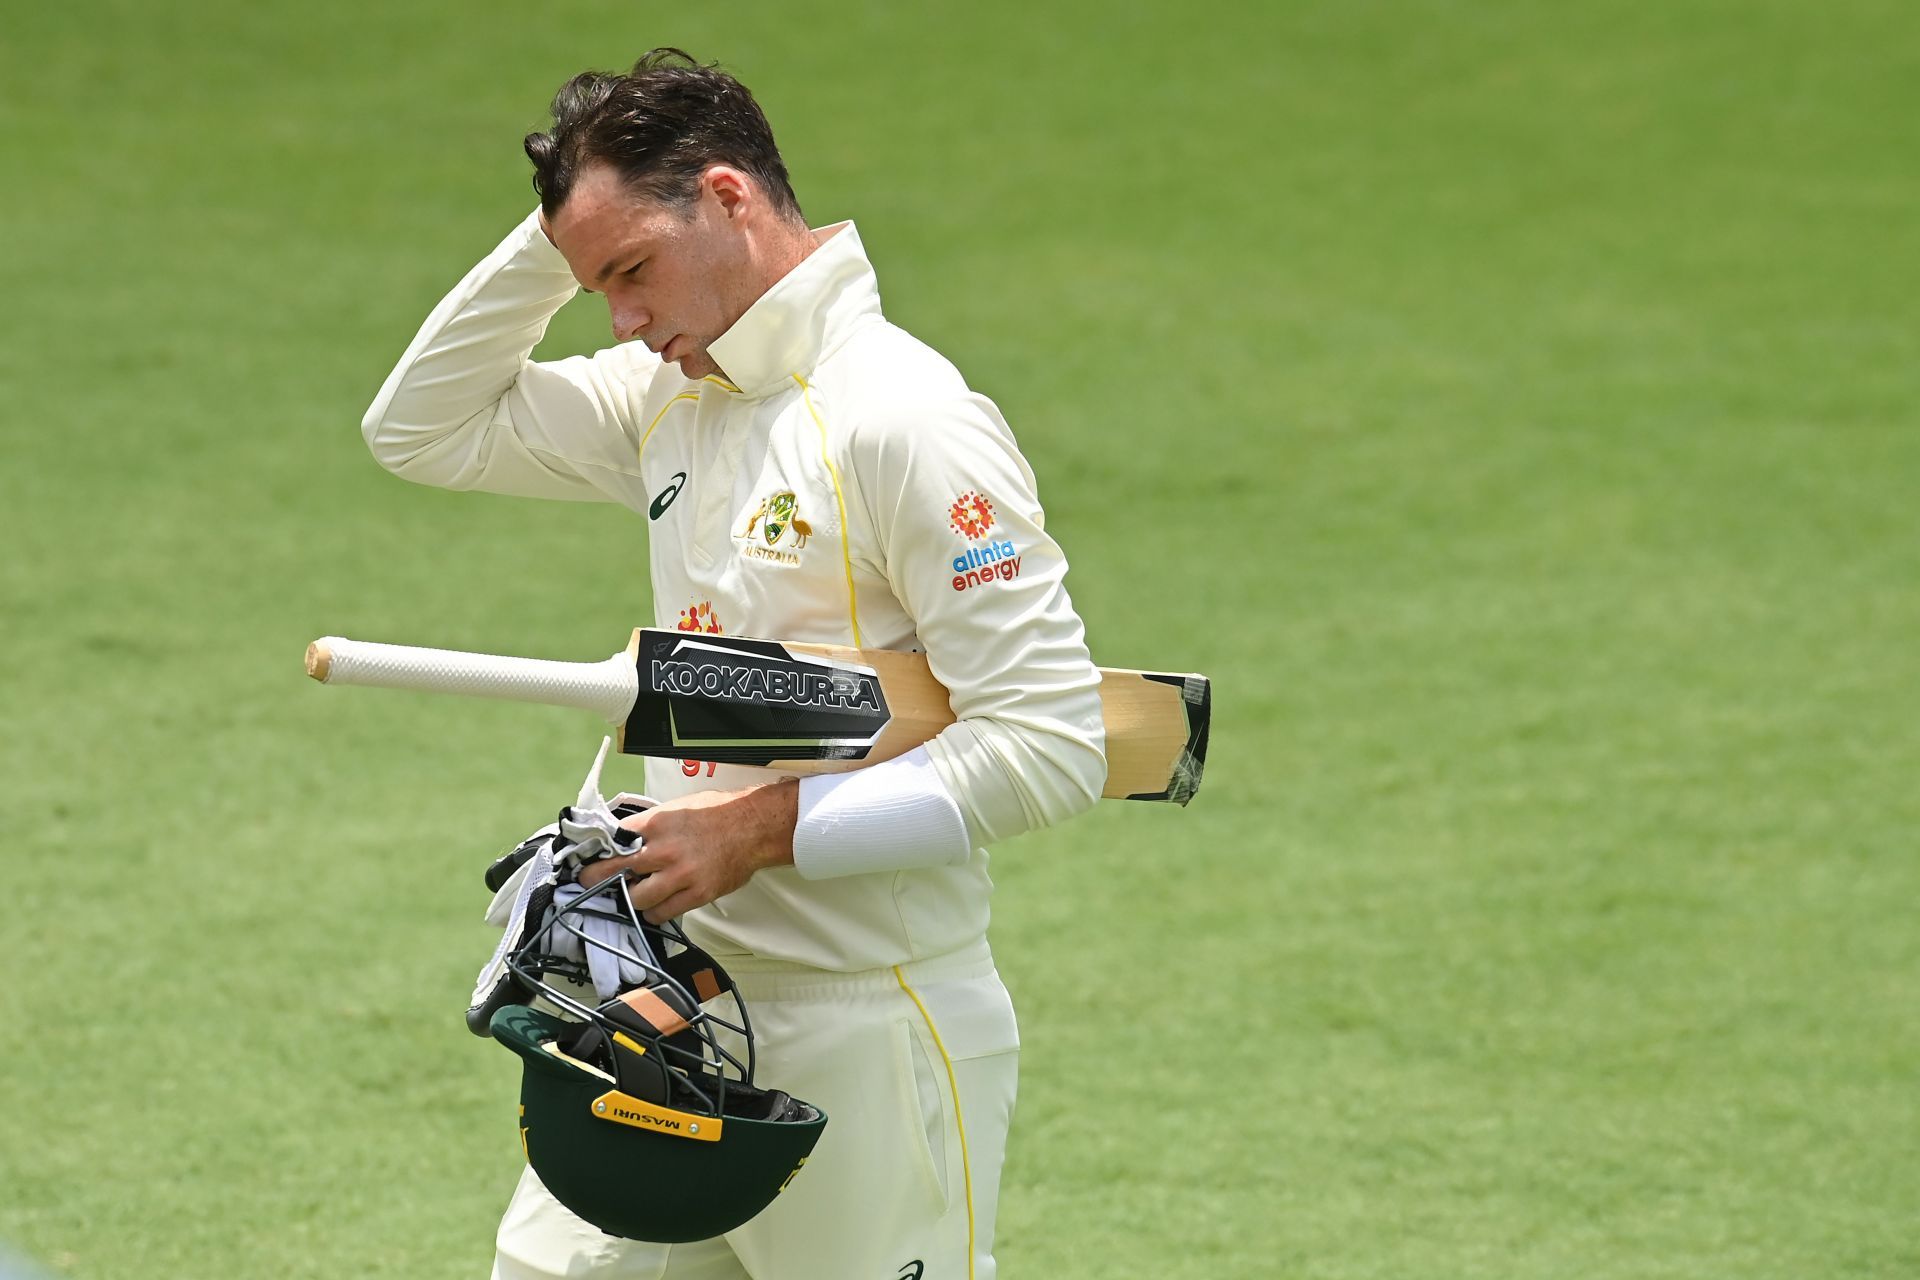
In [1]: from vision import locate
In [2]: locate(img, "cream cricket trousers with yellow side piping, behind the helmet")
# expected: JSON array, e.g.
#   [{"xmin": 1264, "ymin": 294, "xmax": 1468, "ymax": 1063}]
[{"xmin": 493, "ymin": 938, "xmax": 1020, "ymax": 1280}]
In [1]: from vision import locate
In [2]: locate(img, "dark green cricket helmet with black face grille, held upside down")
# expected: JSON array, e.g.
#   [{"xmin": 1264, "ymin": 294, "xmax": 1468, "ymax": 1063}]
[{"xmin": 488, "ymin": 873, "xmax": 828, "ymax": 1244}]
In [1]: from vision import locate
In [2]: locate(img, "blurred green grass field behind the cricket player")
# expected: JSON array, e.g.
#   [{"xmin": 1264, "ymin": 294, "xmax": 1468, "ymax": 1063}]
[{"xmin": 0, "ymin": 0, "xmax": 1920, "ymax": 1280}]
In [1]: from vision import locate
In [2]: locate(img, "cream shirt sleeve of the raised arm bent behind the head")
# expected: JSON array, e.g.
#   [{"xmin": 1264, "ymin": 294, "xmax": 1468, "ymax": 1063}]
[{"xmin": 361, "ymin": 213, "xmax": 660, "ymax": 501}]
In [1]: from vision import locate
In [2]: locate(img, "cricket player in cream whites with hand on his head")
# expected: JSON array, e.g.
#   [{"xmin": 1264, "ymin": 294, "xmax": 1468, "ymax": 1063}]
[{"xmin": 363, "ymin": 50, "xmax": 1106, "ymax": 1280}]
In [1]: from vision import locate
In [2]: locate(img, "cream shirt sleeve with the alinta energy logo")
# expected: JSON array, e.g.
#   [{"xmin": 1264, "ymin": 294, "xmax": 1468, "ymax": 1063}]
[{"xmin": 851, "ymin": 391, "xmax": 1106, "ymax": 844}]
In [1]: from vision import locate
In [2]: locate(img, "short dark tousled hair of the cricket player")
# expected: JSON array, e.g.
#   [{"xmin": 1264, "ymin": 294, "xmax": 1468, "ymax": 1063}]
[{"xmin": 526, "ymin": 48, "xmax": 801, "ymax": 219}]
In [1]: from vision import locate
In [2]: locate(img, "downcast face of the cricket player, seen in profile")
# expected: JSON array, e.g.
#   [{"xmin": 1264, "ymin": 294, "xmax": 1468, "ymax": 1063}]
[{"xmin": 547, "ymin": 165, "xmax": 764, "ymax": 378}]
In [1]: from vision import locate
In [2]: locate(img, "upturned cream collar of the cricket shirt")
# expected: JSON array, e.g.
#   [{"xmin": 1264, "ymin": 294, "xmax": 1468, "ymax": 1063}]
[{"xmin": 707, "ymin": 223, "xmax": 879, "ymax": 399}]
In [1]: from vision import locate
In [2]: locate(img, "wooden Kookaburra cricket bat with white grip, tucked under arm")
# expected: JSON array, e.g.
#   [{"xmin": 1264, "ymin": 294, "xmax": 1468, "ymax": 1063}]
[{"xmin": 307, "ymin": 628, "xmax": 1213, "ymax": 804}]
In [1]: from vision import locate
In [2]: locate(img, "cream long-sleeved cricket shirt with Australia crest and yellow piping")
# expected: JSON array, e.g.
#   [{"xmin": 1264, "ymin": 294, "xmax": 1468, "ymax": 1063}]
[{"xmin": 363, "ymin": 215, "xmax": 1106, "ymax": 971}]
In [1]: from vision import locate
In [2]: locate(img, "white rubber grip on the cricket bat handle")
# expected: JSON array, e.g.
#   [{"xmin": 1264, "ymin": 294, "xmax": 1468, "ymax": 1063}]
[{"xmin": 307, "ymin": 635, "xmax": 639, "ymax": 723}]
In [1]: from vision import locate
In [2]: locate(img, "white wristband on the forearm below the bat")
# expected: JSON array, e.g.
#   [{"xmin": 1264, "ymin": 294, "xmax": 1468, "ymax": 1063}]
[{"xmin": 793, "ymin": 747, "xmax": 973, "ymax": 881}]
